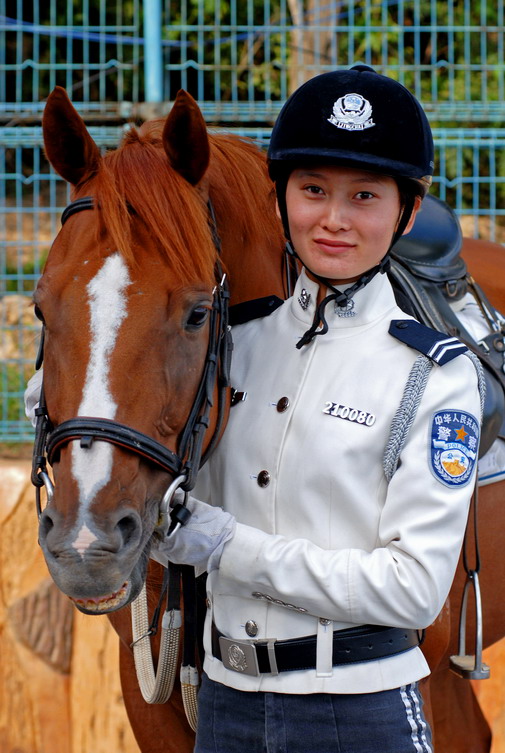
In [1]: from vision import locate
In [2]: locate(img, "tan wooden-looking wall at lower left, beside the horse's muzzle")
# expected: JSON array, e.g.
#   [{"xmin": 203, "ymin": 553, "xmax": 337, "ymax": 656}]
[{"xmin": 0, "ymin": 460, "xmax": 139, "ymax": 753}]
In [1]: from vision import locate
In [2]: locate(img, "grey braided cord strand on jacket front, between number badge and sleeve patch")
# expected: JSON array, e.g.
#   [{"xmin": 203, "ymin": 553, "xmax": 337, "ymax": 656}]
[{"xmin": 382, "ymin": 354, "xmax": 433, "ymax": 483}]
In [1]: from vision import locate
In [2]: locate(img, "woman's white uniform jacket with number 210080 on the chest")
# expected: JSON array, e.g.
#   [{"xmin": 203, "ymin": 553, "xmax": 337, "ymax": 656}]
[{"xmin": 195, "ymin": 272, "xmax": 481, "ymax": 693}]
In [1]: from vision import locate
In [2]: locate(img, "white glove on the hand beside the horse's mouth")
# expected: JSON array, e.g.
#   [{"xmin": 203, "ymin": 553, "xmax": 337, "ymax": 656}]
[{"xmin": 151, "ymin": 495, "xmax": 237, "ymax": 574}]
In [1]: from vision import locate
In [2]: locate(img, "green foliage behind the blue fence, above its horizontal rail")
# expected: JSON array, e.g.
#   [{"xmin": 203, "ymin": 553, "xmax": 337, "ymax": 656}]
[{"xmin": 5, "ymin": 0, "xmax": 504, "ymax": 114}]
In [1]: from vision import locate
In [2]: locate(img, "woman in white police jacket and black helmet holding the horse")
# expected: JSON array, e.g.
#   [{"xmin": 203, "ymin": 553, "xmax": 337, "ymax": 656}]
[{"xmin": 153, "ymin": 65, "xmax": 481, "ymax": 753}]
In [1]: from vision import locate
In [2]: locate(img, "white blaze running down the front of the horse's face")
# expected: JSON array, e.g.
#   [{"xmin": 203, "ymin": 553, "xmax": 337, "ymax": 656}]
[{"xmin": 72, "ymin": 253, "xmax": 131, "ymax": 524}]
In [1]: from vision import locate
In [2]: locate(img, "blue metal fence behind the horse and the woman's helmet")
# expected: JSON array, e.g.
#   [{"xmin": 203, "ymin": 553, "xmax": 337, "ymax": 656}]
[{"xmin": 0, "ymin": 0, "xmax": 505, "ymax": 442}]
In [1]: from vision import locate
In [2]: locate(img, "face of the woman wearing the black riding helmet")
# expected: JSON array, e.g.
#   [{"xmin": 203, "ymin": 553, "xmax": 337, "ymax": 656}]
[{"xmin": 286, "ymin": 166, "xmax": 421, "ymax": 285}]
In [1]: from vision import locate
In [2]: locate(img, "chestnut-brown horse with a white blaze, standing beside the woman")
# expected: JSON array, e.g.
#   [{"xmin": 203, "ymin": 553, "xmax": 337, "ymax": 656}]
[{"xmin": 34, "ymin": 83, "xmax": 505, "ymax": 753}]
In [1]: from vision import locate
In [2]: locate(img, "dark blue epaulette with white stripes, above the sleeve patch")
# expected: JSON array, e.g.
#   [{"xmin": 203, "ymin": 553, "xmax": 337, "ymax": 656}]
[{"xmin": 389, "ymin": 319, "xmax": 468, "ymax": 366}]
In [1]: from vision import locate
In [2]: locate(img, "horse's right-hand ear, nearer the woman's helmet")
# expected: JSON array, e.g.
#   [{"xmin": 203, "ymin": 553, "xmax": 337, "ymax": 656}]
[{"xmin": 163, "ymin": 89, "xmax": 210, "ymax": 186}]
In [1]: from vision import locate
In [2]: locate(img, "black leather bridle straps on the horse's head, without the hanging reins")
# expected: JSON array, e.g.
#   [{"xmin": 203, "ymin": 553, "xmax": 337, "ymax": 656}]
[{"xmin": 31, "ymin": 196, "xmax": 232, "ymax": 533}]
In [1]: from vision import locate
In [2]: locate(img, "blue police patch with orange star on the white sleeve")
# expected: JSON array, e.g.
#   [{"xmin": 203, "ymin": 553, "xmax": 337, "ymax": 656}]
[{"xmin": 430, "ymin": 410, "xmax": 479, "ymax": 486}]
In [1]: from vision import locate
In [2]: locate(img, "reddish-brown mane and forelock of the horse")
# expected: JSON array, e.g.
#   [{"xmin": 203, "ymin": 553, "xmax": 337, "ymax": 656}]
[{"xmin": 84, "ymin": 119, "xmax": 278, "ymax": 281}]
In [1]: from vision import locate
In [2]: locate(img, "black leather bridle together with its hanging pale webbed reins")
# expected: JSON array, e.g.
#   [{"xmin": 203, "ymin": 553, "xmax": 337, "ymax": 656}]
[{"xmin": 31, "ymin": 196, "xmax": 232, "ymax": 716}]
